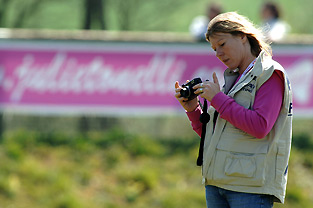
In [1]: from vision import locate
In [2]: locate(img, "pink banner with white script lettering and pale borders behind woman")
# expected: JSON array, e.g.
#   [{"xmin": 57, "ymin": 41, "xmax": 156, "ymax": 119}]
[{"xmin": 0, "ymin": 43, "xmax": 313, "ymax": 115}]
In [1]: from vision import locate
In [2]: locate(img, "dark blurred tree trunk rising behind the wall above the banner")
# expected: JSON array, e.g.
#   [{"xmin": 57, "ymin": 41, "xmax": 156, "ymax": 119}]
[{"xmin": 83, "ymin": 0, "xmax": 106, "ymax": 30}]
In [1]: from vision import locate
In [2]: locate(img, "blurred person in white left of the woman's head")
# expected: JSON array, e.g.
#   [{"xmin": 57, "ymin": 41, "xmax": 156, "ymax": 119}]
[{"xmin": 189, "ymin": 3, "xmax": 222, "ymax": 42}]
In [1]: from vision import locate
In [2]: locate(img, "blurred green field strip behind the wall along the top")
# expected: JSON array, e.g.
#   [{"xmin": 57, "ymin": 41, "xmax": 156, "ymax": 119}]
[{"xmin": 0, "ymin": 0, "xmax": 313, "ymax": 34}]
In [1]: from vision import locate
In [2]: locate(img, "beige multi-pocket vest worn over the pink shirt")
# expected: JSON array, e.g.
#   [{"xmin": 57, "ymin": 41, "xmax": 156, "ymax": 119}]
[{"xmin": 202, "ymin": 52, "xmax": 292, "ymax": 203}]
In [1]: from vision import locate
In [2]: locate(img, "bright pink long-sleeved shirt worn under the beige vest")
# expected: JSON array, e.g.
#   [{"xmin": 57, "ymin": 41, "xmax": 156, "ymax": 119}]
[{"xmin": 187, "ymin": 70, "xmax": 284, "ymax": 138}]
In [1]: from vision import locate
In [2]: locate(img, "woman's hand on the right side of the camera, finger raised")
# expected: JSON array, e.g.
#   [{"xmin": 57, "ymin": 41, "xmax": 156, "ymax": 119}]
[{"xmin": 193, "ymin": 72, "xmax": 221, "ymax": 102}]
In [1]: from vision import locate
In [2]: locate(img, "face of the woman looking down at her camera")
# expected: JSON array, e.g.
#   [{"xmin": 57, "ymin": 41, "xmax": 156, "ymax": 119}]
[{"xmin": 210, "ymin": 33, "xmax": 247, "ymax": 70}]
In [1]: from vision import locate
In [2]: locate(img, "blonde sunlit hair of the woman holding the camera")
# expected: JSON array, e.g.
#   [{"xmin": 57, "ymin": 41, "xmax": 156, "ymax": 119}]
[{"xmin": 205, "ymin": 12, "xmax": 272, "ymax": 56}]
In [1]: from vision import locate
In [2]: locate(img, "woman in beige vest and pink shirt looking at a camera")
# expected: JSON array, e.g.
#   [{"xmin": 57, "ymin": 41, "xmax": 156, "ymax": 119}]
[{"xmin": 175, "ymin": 12, "xmax": 292, "ymax": 208}]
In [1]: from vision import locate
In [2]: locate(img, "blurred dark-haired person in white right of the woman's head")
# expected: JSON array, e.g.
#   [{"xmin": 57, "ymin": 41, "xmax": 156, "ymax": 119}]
[{"xmin": 261, "ymin": 2, "xmax": 290, "ymax": 42}]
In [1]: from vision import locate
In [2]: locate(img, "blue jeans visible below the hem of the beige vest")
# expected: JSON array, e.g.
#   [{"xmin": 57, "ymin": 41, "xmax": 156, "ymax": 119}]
[{"xmin": 205, "ymin": 186, "xmax": 273, "ymax": 208}]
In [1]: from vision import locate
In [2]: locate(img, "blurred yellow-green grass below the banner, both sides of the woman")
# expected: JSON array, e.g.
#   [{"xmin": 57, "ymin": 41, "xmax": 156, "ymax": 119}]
[{"xmin": 0, "ymin": 118, "xmax": 313, "ymax": 208}]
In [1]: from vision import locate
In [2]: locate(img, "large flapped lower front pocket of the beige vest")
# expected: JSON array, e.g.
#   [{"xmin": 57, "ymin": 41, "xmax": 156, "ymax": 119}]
[{"xmin": 213, "ymin": 149, "xmax": 265, "ymax": 186}]
